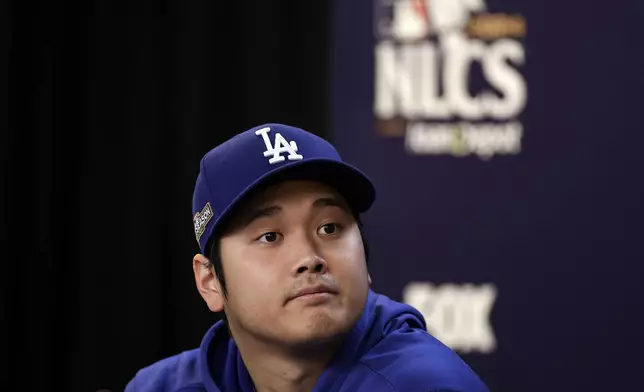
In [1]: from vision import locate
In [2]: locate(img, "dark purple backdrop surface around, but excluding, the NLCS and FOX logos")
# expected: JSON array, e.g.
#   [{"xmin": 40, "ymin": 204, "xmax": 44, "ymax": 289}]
[{"xmin": 332, "ymin": 0, "xmax": 644, "ymax": 392}]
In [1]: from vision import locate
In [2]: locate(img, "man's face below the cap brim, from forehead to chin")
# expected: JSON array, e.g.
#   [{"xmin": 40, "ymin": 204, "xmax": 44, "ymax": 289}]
[{"xmin": 220, "ymin": 182, "xmax": 370, "ymax": 344}]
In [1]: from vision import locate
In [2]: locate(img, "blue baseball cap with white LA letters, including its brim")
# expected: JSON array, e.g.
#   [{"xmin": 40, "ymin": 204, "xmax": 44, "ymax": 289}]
[{"xmin": 192, "ymin": 123, "xmax": 376, "ymax": 254}]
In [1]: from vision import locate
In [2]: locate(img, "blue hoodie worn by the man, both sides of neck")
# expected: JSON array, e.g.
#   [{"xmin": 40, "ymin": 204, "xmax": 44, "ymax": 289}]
[{"xmin": 125, "ymin": 290, "xmax": 489, "ymax": 392}]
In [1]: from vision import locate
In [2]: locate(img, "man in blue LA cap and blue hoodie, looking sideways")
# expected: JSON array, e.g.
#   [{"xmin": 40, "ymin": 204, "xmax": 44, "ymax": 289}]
[{"xmin": 126, "ymin": 124, "xmax": 488, "ymax": 392}]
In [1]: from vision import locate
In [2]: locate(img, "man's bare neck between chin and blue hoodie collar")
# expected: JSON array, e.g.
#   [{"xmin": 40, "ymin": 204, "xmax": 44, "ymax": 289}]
[{"xmin": 234, "ymin": 336, "xmax": 335, "ymax": 392}]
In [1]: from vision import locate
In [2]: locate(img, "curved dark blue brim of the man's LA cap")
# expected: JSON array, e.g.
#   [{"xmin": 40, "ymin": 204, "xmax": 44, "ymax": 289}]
[{"xmin": 209, "ymin": 158, "xmax": 376, "ymax": 238}]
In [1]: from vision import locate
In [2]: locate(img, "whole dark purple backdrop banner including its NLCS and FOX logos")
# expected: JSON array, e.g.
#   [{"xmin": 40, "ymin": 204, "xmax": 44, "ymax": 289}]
[{"xmin": 332, "ymin": 0, "xmax": 644, "ymax": 392}]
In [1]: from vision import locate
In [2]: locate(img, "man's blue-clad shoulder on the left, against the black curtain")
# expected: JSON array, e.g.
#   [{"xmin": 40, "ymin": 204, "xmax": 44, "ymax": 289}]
[{"xmin": 125, "ymin": 349, "xmax": 205, "ymax": 392}]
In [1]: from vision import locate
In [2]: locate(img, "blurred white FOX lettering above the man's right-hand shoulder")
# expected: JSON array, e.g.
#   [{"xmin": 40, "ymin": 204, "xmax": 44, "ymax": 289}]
[{"xmin": 404, "ymin": 282, "xmax": 496, "ymax": 353}]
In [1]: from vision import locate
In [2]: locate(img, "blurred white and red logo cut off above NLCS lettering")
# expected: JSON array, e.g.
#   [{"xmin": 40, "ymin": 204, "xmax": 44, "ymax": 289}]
[{"xmin": 391, "ymin": 0, "xmax": 486, "ymax": 41}]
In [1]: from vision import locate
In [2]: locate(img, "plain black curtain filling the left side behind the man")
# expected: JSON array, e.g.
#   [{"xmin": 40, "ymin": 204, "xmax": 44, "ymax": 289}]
[{"xmin": 6, "ymin": 1, "xmax": 330, "ymax": 392}]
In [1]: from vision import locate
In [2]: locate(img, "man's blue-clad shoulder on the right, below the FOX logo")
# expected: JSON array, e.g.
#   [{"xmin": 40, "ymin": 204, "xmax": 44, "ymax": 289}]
[{"xmin": 360, "ymin": 329, "xmax": 489, "ymax": 392}]
